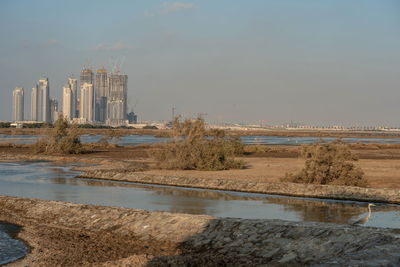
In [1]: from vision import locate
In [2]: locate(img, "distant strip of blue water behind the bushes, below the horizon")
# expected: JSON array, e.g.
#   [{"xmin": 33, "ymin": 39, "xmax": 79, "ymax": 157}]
[{"xmin": 0, "ymin": 134, "xmax": 400, "ymax": 145}]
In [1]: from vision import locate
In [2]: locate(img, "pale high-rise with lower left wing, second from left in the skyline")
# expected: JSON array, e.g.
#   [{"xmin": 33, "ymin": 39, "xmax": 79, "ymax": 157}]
[{"xmin": 32, "ymin": 78, "xmax": 51, "ymax": 122}]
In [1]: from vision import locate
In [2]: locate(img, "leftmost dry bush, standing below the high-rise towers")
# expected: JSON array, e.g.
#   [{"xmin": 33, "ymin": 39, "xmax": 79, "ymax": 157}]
[{"xmin": 33, "ymin": 116, "xmax": 83, "ymax": 154}]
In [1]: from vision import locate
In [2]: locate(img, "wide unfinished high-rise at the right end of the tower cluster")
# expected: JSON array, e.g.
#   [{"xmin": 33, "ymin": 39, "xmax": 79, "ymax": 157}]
[{"xmin": 107, "ymin": 73, "xmax": 128, "ymax": 125}]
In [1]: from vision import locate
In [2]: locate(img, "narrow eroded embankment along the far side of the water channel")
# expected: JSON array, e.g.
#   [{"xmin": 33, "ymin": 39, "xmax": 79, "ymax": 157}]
[{"xmin": 79, "ymin": 170, "xmax": 400, "ymax": 204}]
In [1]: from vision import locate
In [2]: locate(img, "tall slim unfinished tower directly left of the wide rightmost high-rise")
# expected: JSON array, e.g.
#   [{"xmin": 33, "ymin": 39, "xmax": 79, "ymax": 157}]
[{"xmin": 95, "ymin": 68, "xmax": 108, "ymax": 122}]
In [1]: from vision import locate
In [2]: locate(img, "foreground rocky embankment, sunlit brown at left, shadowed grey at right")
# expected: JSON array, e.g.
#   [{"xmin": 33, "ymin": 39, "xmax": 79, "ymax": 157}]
[{"xmin": 0, "ymin": 197, "xmax": 400, "ymax": 266}]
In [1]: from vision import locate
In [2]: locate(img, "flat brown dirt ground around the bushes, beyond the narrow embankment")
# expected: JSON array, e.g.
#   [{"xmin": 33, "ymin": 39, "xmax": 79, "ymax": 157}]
[{"xmin": 0, "ymin": 144, "xmax": 400, "ymax": 188}]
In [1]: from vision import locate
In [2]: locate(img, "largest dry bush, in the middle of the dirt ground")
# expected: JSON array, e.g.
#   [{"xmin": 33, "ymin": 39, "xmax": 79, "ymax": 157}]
[{"xmin": 151, "ymin": 118, "xmax": 245, "ymax": 170}]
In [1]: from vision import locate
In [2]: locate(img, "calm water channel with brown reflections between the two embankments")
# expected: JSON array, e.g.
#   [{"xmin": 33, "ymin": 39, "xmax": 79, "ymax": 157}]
[{"xmin": 0, "ymin": 162, "xmax": 400, "ymax": 228}]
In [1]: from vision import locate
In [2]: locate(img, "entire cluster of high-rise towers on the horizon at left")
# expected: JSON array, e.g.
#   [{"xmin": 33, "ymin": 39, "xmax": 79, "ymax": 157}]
[{"xmin": 13, "ymin": 68, "xmax": 132, "ymax": 126}]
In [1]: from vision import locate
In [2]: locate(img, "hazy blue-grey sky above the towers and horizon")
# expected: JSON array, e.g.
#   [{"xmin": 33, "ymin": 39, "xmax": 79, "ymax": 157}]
[{"xmin": 0, "ymin": 0, "xmax": 400, "ymax": 126}]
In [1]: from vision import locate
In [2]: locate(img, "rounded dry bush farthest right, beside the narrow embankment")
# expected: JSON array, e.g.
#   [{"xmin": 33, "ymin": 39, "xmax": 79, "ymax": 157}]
[{"xmin": 282, "ymin": 140, "xmax": 368, "ymax": 187}]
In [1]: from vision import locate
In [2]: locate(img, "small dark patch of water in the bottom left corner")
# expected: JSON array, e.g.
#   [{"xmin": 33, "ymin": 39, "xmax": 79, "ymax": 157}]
[{"xmin": 0, "ymin": 221, "xmax": 28, "ymax": 265}]
